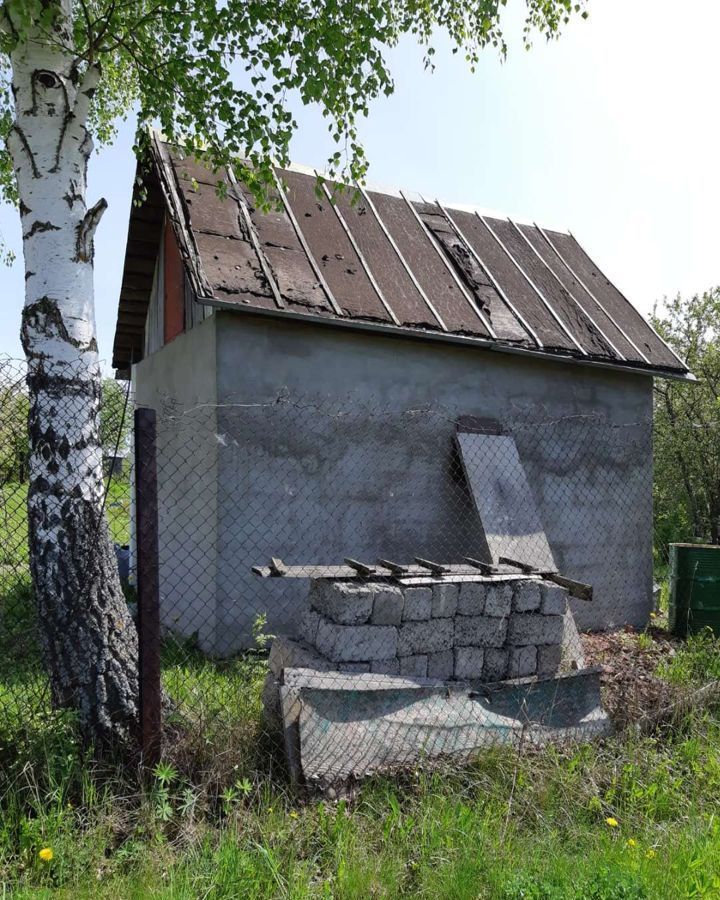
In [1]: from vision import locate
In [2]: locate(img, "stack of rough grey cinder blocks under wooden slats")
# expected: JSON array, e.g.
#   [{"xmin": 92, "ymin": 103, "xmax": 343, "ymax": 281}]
[{"xmin": 294, "ymin": 578, "xmax": 582, "ymax": 681}]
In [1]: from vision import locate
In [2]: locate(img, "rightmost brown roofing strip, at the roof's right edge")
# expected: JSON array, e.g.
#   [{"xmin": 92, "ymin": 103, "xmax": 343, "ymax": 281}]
[{"xmin": 546, "ymin": 231, "xmax": 680, "ymax": 367}]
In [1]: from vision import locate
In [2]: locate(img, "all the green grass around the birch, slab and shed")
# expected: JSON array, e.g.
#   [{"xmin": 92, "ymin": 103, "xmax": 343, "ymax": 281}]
[{"xmin": 0, "ymin": 496, "xmax": 720, "ymax": 900}]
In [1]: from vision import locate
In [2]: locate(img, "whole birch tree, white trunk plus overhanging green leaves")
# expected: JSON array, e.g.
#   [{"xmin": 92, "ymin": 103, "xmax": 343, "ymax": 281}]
[{"xmin": 0, "ymin": 0, "xmax": 585, "ymax": 748}]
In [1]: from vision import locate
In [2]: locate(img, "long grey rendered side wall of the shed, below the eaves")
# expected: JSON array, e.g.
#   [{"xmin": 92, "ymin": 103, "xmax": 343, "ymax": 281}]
[{"xmin": 207, "ymin": 312, "xmax": 652, "ymax": 652}]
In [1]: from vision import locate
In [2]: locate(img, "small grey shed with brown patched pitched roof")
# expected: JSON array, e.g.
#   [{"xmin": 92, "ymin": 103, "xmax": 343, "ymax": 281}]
[{"xmin": 113, "ymin": 138, "xmax": 692, "ymax": 654}]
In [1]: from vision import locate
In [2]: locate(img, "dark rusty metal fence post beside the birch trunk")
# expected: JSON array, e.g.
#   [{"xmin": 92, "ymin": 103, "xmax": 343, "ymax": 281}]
[{"xmin": 135, "ymin": 409, "xmax": 162, "ymax": 767}]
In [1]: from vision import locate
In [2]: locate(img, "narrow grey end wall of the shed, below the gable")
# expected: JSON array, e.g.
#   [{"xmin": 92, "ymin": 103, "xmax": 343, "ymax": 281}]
[{"xmin": 132, "ymin": 317, "xmax": 218, "ymax": 650}]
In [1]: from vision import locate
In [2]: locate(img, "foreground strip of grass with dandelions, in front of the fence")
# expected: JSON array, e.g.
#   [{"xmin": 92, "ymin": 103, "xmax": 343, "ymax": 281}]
[{"xmin": 0, "ymin": 713, "xmax": 720, "ymax": 900}]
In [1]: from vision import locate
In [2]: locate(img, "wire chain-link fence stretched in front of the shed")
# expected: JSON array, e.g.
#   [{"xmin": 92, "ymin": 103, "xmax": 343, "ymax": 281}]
[{"xmin": 0, "ymin": 352, "xmax": 716, "ymax": 786}]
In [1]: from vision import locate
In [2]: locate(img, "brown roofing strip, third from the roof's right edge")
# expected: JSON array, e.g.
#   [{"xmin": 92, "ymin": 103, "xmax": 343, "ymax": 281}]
[{"xmin": 487, "ymin": 218, "xmax": 620, "ymax": 358}]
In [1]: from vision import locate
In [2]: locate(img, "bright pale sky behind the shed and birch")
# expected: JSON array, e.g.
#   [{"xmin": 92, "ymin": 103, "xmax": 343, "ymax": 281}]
[{"xmin": 0, "ymin": 0, "xmax": 720, "ymax": 371}]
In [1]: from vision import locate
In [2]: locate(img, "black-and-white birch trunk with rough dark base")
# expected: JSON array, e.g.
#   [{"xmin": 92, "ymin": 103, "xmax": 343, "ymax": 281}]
[{"xmin": 8, "ymin": 0, "xmax": 138, "ymax": 747}]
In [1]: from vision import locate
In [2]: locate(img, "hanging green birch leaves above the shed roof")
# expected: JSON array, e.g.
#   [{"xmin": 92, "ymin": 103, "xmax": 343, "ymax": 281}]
[{"xmin": 0, "ymin": 0, "xmax": 587, "ymax": 206}]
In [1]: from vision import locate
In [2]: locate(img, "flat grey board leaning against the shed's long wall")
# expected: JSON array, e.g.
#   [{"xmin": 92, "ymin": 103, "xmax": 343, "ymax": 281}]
[{"xmin": 457, "ymin": 431, "xmax": 557, "ymax": 571}]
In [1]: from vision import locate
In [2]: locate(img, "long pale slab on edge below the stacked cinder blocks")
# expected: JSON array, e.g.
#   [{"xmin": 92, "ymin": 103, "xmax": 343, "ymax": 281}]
[{"xmin": 280, "ymin": 669, "xmax": 611, "ymax": 784}]
